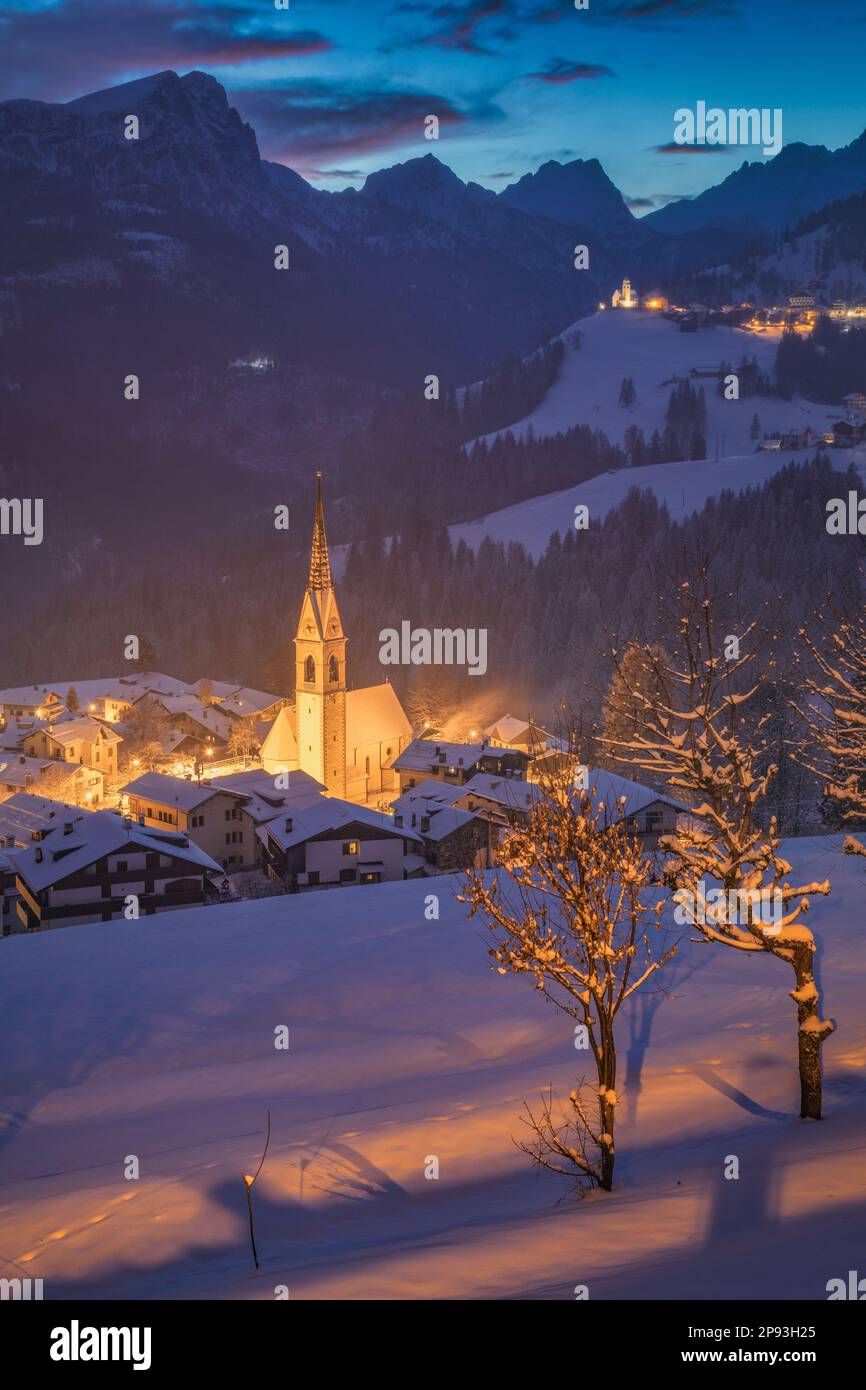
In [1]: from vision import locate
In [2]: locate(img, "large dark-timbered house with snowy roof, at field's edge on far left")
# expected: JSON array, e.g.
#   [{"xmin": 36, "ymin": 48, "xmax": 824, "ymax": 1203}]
[{"xmin": 11, "ymin": 810, "xmax": 220, "ymax": 931}]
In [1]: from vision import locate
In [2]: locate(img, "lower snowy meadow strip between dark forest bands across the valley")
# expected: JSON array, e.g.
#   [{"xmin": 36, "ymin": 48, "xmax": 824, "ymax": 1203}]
[{"xmin": 449, "ymin": 442, "xmax": 866, "ymax": 559}]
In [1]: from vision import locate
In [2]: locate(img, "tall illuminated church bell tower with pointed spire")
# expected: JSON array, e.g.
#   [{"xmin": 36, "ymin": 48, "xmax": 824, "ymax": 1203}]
[{"xmin": 295, "ymin": 473, "xmax": 346, "ymax": 796}]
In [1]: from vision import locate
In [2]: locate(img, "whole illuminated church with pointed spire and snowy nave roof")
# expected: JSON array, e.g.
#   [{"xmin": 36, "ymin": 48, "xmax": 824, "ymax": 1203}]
[{"xmin": 261, "ymin": 474, "xmax": 413, "ymax": 805}]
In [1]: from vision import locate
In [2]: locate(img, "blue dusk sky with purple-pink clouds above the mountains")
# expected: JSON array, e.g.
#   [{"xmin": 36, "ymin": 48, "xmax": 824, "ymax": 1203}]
[{"xmin": 0, "ymin": 0, "xmax": 866, "ymax": 205}]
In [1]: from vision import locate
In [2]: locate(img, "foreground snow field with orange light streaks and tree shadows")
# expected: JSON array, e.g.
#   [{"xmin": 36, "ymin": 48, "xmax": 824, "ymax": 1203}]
[{"xmin": 0, "ymin": 838, "xmax": 866, "ymax": 1300}]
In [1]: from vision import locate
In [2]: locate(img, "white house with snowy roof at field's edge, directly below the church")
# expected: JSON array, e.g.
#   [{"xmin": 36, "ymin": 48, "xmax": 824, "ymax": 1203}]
[{"xmin": 257, "ymin": 796, "xmax": 423, "ymax": 891}]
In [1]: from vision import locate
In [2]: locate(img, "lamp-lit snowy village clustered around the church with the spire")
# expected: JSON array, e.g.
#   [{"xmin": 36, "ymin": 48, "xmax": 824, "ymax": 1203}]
[{"xmin": 0, "ymin": 480, "xmax": 683, "ymax": 935}]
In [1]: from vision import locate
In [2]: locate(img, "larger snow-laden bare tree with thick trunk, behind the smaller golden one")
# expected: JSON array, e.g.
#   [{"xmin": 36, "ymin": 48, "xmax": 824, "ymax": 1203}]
[{"xmin": 603, "ymin": 560, "xmax": 833, "ymax": 1119}]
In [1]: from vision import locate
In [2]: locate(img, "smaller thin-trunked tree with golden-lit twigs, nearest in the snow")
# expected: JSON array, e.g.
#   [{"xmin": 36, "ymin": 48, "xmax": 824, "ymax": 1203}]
[{"xmin": 460, "ymin": 774, "xmax": 676, "ymax": 1191}]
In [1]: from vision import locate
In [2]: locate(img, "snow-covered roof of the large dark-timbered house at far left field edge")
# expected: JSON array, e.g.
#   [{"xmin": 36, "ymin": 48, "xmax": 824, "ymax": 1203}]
[{"xmin": 15, "ymin": 810, "xmax": 222, "ymax": 892}]
